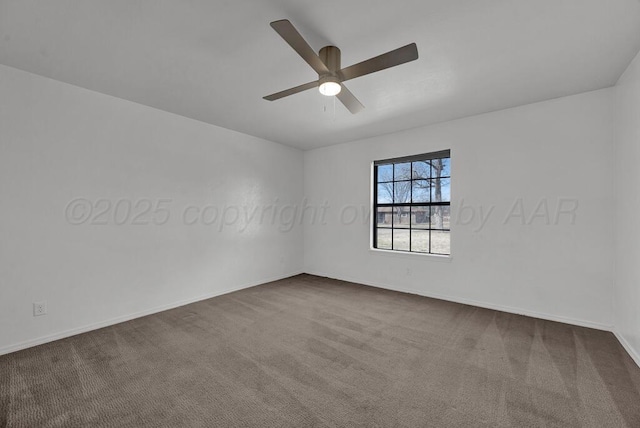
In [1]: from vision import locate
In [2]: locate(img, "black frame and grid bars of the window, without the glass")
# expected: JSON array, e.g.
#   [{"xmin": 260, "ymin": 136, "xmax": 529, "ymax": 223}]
[{"xmin": 371, "ymin": 149, "xmax": 451, "ymax": 258}]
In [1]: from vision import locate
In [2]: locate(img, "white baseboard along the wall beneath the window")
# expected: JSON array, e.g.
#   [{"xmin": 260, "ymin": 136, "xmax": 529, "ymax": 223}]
[{"xmin": 306, "ymin": 271, "xmax": 613, "ymax": 331}]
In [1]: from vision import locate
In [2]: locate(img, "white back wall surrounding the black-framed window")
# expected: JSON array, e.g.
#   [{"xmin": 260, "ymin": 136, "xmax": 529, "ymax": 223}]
[{"xmin": 304, "ymin": 89, "xmax": 614, "ymax": 329}]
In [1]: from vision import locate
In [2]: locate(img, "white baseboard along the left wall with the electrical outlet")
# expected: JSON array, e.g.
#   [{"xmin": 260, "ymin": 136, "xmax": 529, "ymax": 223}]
[{"xmin": 0, "ymin": 271, "xmax": 304, "ymax": 355}]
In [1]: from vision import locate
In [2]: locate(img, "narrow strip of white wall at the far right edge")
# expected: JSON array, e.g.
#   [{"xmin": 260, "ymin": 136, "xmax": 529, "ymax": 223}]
[{"xmin": 614, "ymin": 50, "xmax": 640, "ymax": 365}]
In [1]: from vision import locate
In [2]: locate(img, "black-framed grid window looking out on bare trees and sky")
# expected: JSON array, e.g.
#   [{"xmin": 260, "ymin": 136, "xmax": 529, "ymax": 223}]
[{"xmin": 373, "ymin": 150, "xmax": 451, "ymax": 255}]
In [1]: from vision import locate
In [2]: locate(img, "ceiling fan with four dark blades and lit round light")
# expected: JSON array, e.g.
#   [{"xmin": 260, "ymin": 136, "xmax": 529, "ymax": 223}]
[{"xmin": 263, "ymin": 19, "xmax": 418, "ymax": 114}]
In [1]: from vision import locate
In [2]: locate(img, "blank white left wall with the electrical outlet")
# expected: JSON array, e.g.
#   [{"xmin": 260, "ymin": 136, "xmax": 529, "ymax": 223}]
[{"xmin": 0, "ymin": 66, "xmax": 303, "ymax": 353}]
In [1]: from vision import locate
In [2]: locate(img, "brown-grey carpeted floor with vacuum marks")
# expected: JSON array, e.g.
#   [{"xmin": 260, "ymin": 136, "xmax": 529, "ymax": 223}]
[{"xmin": 0, "ymin": 275, "xmax": 640, "ymax": 428}]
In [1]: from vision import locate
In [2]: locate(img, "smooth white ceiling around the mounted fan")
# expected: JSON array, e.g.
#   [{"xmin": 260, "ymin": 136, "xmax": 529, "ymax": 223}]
[{"xmin": 0, "ymin": 0, "xmax": 640, "ymax": 149}]
